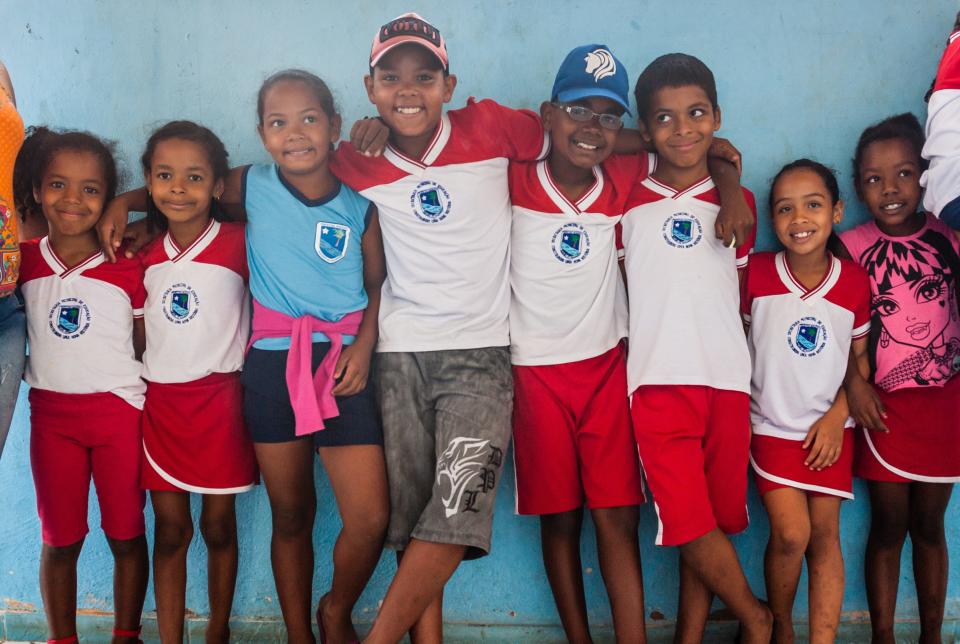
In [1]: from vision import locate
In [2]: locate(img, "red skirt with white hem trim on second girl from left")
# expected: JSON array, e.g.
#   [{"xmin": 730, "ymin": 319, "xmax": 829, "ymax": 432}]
[{"xmin": 140, "ymin": 373, "xmax": 257, "ymax": 494}]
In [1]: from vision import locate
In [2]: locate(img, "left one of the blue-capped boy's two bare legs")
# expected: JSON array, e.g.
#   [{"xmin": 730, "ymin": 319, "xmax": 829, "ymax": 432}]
[{"xmin": 540, "ymin": 508, "xmax": 592, "ymax": 644}]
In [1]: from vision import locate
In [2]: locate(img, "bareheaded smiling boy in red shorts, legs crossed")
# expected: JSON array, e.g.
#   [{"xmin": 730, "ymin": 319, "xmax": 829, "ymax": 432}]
[{"xmin": 623, "ymin": 54, "xmax": 772, "ymax": 643}]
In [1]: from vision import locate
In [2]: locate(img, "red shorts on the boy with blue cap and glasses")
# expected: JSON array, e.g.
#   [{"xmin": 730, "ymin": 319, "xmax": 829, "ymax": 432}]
[{"xmin": 513, "ymin": 346, "xmax": 643, "ymax": 514}]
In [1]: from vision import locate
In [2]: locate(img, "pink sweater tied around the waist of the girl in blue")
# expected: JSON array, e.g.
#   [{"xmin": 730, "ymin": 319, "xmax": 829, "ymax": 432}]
[{"xmin": 247, "ymin": 300, "xmax": 363, "ymax": 436}]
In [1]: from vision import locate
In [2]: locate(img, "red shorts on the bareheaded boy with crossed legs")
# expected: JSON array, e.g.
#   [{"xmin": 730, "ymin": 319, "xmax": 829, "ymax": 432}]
[{"xmin": 630, "ymin": 385, "xmax": 750, "ymax": 546}]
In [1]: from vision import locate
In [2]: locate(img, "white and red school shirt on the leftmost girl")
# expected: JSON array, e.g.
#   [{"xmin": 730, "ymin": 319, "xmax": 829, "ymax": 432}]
[{"xmin": 20, "ymin": 237, "xmax": 146, "ymax": 409}]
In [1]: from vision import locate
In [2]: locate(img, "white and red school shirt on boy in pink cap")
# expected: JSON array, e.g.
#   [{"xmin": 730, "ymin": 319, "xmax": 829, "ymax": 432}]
[{"xmin": 331, "ymin": 99, "xmax": 546, "ymax": 351}]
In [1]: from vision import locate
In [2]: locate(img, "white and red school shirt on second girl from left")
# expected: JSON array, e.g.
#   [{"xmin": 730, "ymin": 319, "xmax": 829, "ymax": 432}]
[{"xmin": 142, "ymin": 219, "xmax": 250, "ymax": 383}]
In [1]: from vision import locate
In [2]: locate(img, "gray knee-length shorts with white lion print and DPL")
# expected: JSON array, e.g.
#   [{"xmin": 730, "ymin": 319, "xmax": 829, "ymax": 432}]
[{"xmin": 376, "ymin": 347, "xmax": 513, "ymax": 559}]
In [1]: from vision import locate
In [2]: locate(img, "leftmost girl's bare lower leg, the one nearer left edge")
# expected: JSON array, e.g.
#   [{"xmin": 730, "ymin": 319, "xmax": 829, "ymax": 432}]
[{"xmin": 40, "ymin": 539, "xmax": 83, "ymax": 639}]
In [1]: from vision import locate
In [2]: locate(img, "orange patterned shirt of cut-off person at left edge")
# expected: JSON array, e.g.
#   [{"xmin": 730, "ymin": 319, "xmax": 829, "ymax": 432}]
[{"xmin": 0, "ymin": 91, "xmax": 23, "ymax": 297}]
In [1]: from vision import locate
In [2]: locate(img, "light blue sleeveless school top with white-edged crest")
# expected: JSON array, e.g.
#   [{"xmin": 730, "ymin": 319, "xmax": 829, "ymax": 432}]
[{"xmin": 243, "ymin": 165, "xmax": 372, "ymax": 350}]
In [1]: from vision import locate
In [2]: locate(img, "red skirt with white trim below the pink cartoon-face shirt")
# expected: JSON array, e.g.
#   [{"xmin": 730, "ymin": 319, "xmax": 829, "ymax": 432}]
[{"xmin": 853, "ymin": 375, "xmax": 960, "ymax": 483}]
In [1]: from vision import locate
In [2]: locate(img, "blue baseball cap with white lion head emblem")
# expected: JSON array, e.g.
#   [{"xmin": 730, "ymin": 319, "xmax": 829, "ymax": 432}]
[{"xmin": 550, "ymin": 45, "xmax": 630, "ymax": 114}]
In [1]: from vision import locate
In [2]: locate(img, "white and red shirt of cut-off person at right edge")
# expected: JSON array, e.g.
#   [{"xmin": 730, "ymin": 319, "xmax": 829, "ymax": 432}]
[{"xmin": 920, "ymin": 31, "xmax": 960, "ymax": 217}]
